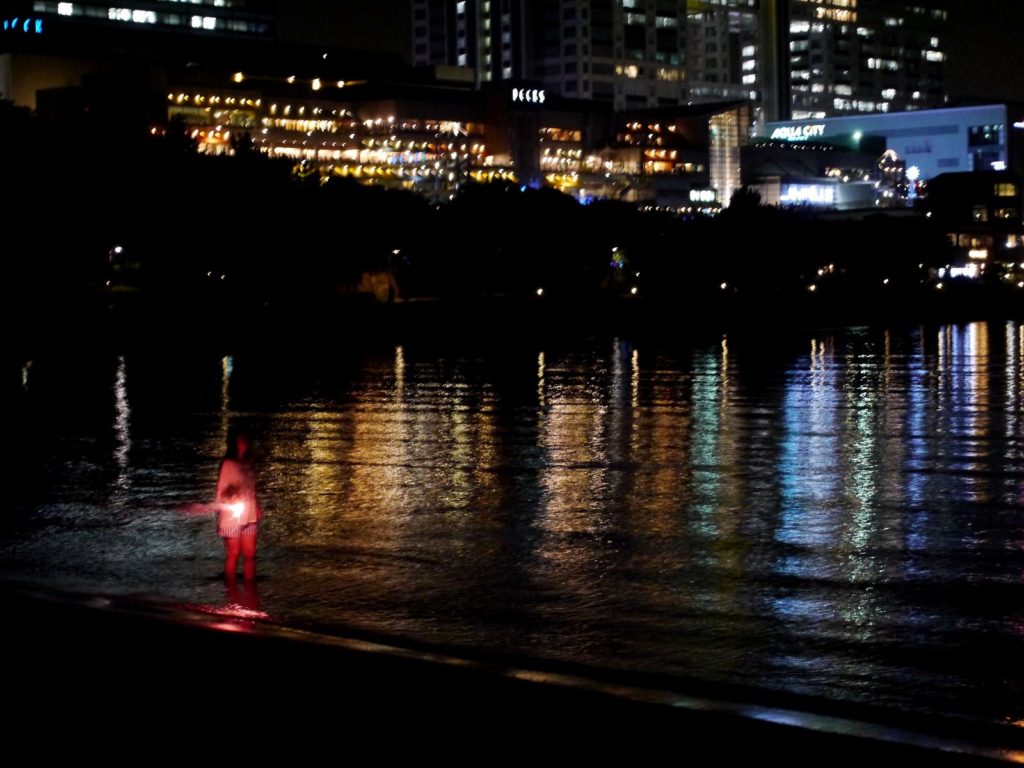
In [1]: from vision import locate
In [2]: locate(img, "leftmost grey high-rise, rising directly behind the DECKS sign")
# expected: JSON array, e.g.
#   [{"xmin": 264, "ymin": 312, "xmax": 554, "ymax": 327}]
[{"xmin": 413, "ymin": 0, "xmax": 687, "ymax": 109}]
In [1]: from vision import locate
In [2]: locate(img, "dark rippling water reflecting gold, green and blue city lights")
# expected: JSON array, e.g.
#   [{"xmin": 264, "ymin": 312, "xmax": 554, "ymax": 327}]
[{"xmin": 0, "ymin": 323, "xmax": 1024, "ymax": 722}]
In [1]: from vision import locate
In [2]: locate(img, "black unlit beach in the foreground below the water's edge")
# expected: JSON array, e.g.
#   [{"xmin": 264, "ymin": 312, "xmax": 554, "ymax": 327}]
[{"xmin": 0, "ymin": 588, "xmax": 1024, "ymax": 766}]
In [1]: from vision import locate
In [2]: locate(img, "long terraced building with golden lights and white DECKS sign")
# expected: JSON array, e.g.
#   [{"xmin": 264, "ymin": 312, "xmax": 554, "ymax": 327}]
[{"xmin": 157, "ymin": 67, "xmax": 749, "ymax": 208}]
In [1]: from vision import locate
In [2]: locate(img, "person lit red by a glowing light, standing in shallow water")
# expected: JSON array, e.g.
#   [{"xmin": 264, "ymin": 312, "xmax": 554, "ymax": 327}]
[{"xmin": 216, "ymin": 427, "xmax": 263, "ymax": 583}]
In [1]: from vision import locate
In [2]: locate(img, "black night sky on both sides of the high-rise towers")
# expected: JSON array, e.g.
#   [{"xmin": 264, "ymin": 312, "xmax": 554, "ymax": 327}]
[{"xmin": 278, "ymin": 0, "xmax": 1024, "ymax": 101}]
